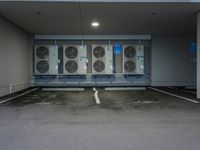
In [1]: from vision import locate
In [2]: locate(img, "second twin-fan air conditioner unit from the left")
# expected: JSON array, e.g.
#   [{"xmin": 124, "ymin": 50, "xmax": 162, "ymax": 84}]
[{"xmin": 63, "ymin": 45, "xmax": 88, "ymax": 75}]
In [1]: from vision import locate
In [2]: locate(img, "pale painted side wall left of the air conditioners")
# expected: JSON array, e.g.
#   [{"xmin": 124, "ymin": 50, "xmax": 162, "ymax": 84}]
[{"xmin": 0, "ymin": 17, "xmax": 32, "ymax": 97}]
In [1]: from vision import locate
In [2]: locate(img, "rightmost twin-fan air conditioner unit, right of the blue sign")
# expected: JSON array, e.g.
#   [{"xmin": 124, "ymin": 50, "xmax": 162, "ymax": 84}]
[{"xmin": 123, "ymin": 45, "xmax": 144, "ymax": 74}]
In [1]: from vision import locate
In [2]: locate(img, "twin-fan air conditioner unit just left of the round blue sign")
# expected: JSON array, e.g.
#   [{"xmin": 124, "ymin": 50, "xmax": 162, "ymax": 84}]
[{"xmin": 92, "ymin": 45, "xmax": 113, "ymax": 74}]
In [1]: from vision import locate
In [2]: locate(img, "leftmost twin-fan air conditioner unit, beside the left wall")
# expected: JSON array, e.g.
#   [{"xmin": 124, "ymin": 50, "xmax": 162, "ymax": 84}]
[{"xmin": 34, "ymin": 45, "xmax": 59, "ymax": 75}]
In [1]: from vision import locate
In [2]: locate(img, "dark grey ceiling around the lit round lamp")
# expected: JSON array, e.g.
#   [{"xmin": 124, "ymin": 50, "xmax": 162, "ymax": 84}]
[{"xmin": 0, "ymin": 2, "xmax": 200, "ymax": 35}]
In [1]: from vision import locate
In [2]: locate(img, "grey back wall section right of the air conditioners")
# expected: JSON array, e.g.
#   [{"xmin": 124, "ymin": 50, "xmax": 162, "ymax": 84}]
[{"xmin": 151, "ymin": 36, "xmax": 196, "ymax": 86}]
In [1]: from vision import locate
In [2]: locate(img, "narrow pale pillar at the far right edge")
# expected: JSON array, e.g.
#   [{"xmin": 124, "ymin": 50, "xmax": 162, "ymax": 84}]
[{"xmin": 197, "ymin": 13, "xmax": 200, "ymax": 99}]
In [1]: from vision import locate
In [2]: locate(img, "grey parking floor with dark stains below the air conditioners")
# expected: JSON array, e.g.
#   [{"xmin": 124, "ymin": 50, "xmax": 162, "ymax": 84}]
[{"xmin": 0, "ymin": 89, "xmax": 200, "ymax": 150}]
